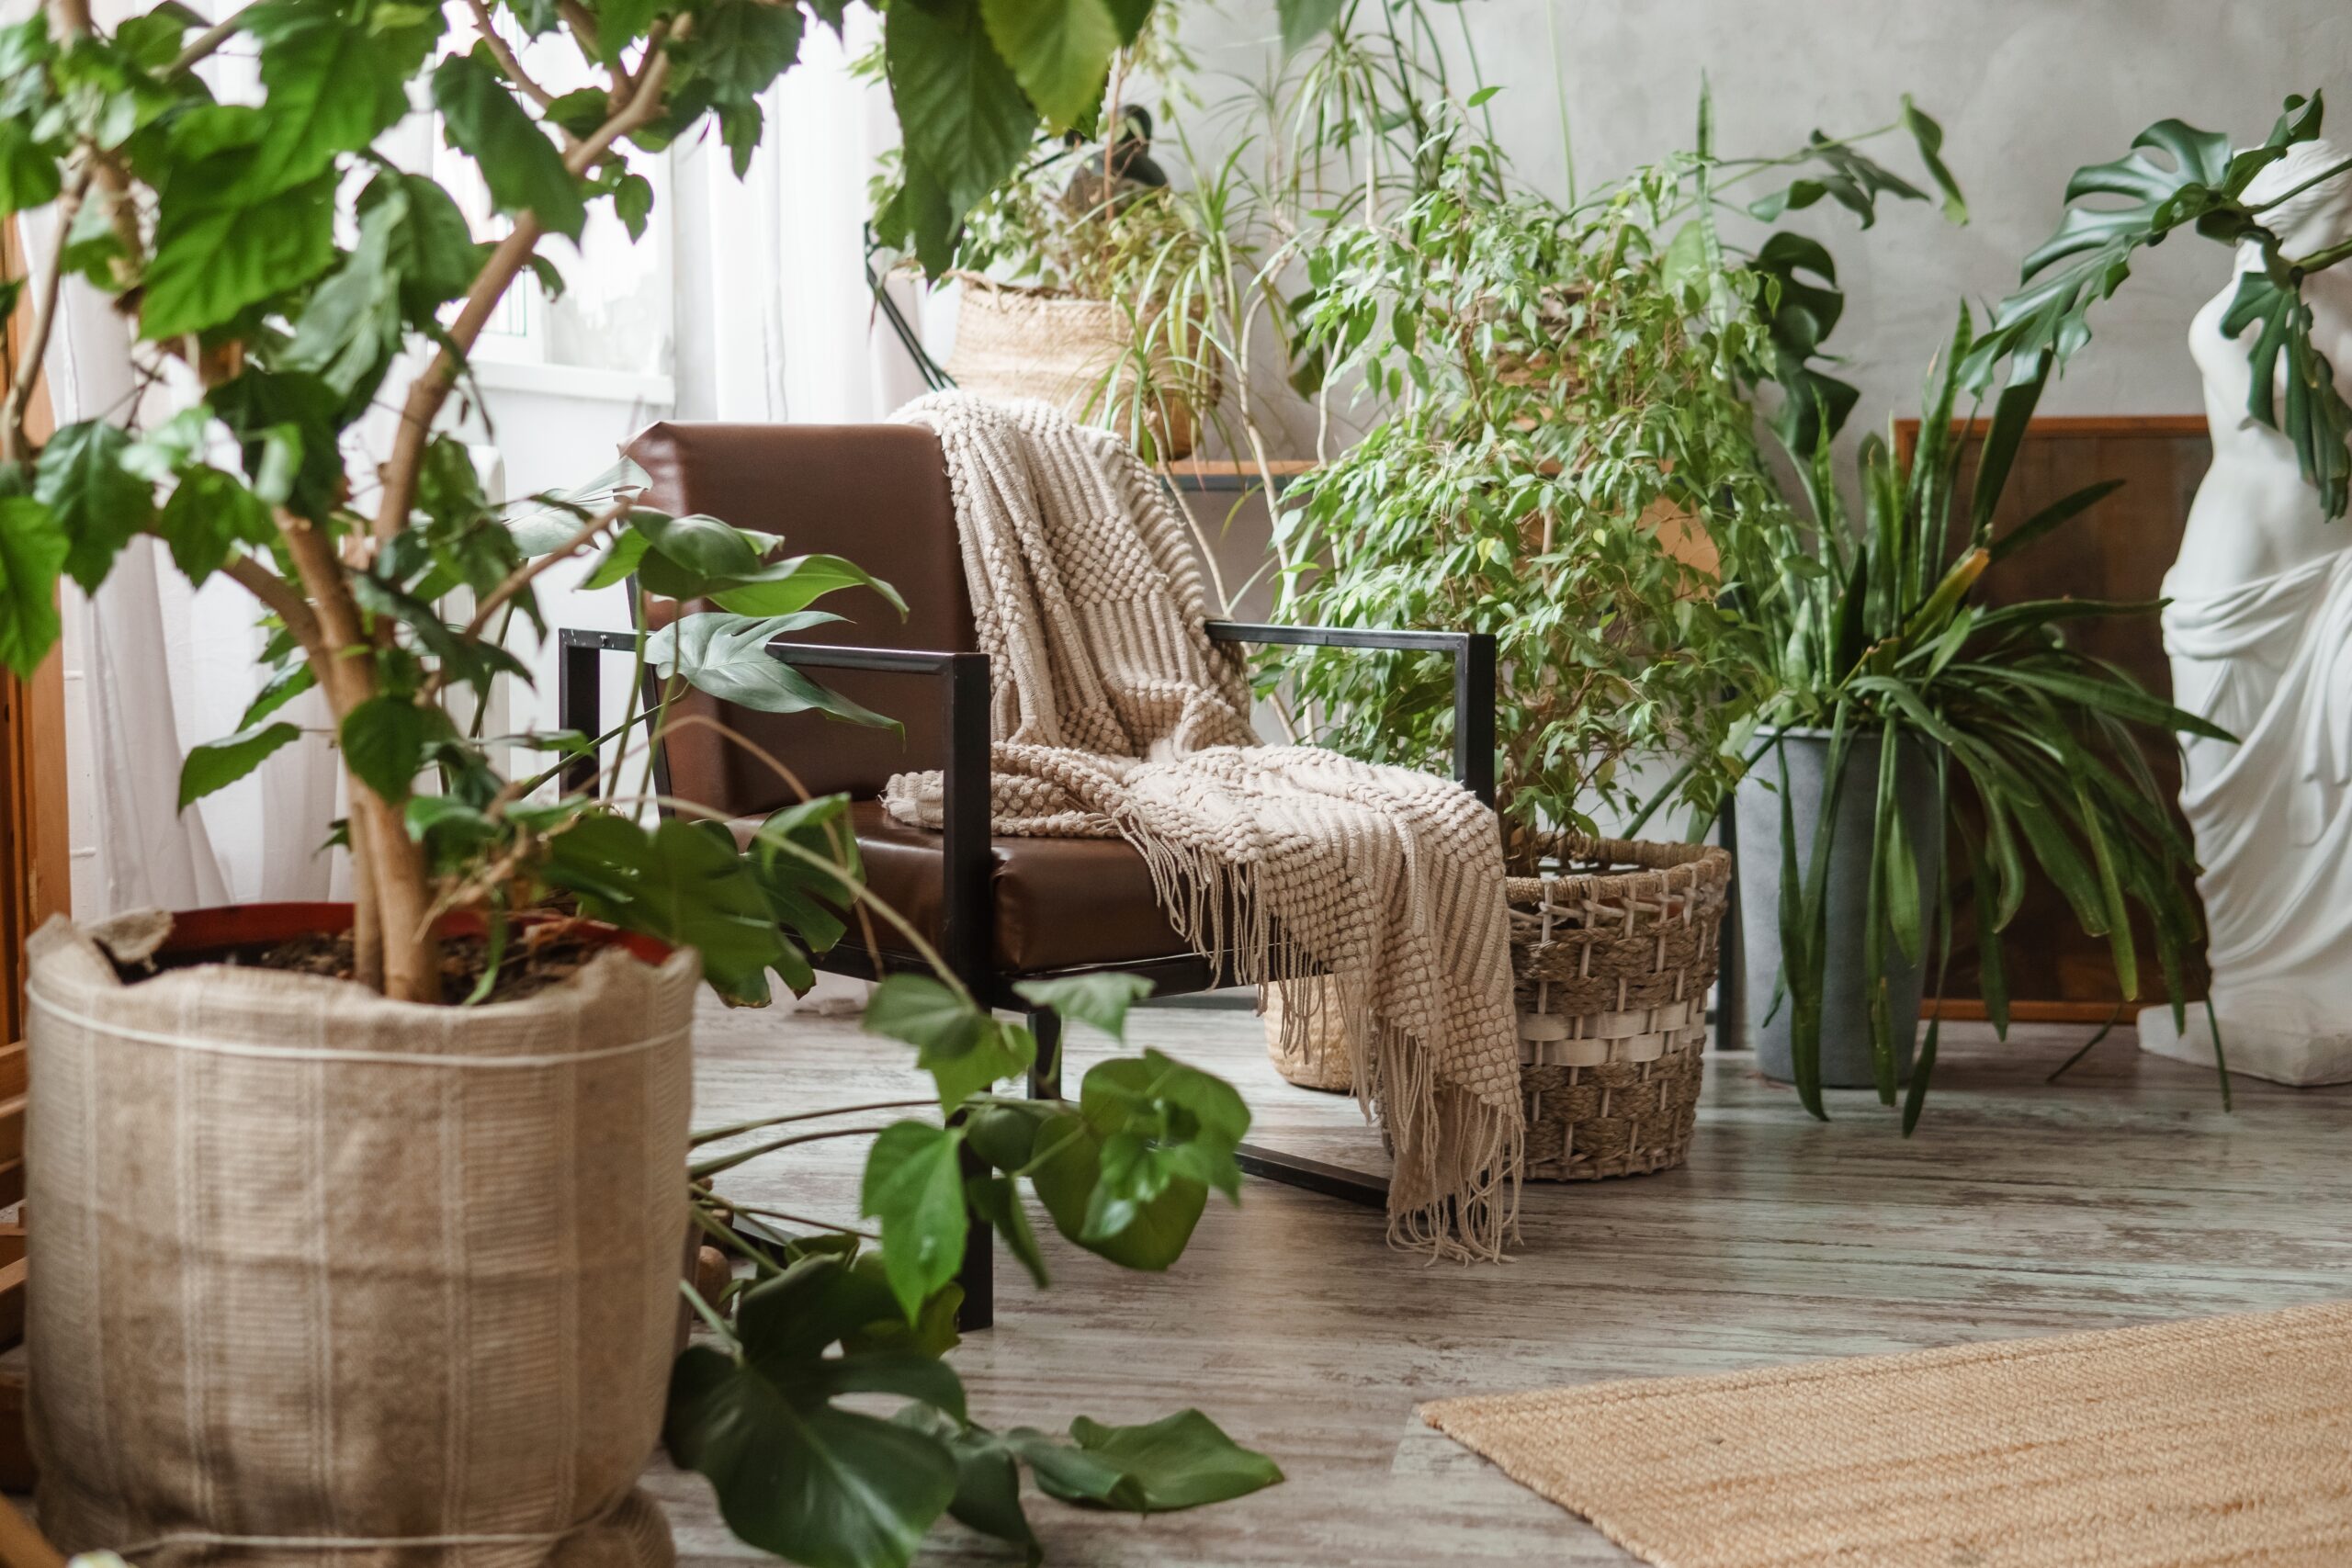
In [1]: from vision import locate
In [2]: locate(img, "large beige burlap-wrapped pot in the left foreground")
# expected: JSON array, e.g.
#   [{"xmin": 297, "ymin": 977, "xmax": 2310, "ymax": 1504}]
[{"xmin": 26, "ymin": 905, "xmax": 698, "ymax": 1568}]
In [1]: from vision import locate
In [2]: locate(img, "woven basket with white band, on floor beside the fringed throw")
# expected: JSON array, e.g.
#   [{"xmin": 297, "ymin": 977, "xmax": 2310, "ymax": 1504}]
[{"xmin": 1505, "ymin": 840, "xmax": 1731, "ymax": 1182}]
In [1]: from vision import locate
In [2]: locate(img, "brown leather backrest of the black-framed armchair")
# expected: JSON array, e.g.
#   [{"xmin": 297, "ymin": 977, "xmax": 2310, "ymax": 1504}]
[{"xmin": 628, "ymin": 423, "xmax": 978, "ymax": 816}]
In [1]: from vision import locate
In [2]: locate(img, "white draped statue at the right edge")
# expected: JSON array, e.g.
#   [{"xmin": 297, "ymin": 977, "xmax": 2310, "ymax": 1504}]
[{"xmin": 2141, "ymin": 141, "xmax": 2352, "ymax": 1084}]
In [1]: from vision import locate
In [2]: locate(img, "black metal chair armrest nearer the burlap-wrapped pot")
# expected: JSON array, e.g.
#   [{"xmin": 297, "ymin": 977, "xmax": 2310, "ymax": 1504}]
[{"xmin": 555, "ymin": 627, "xmax": 995, "ymax": 989}]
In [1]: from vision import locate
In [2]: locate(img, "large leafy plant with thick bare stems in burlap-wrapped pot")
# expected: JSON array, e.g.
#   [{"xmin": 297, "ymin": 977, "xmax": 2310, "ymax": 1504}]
[{"xmin": 0, "ymin": 0, "xmax": 1272, "ymax": 1563}]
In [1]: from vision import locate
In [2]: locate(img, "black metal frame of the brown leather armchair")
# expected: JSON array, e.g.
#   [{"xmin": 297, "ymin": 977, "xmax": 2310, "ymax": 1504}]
[{"xmin": 555, "ymin": 621, "xmax": 1496, "ymax": 1331}]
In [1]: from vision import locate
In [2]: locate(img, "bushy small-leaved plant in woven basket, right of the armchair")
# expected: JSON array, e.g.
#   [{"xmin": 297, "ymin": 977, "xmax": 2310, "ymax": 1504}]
[{"xmin": 1280, "ymin": 83, "xmax": 1964, "ymax": 1152}]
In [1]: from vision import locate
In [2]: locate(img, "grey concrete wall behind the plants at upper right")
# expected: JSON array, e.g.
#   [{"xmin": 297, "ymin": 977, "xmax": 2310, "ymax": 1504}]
[{"xmin": 1188, "ymin": 0, "xmax": 2352, "ymax": 444}]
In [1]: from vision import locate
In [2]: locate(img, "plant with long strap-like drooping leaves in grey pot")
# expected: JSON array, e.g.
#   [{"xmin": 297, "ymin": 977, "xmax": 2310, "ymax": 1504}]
[{"xmin": 1722, "ymin": 308, "xmax": 2232, "ymax": 1134}]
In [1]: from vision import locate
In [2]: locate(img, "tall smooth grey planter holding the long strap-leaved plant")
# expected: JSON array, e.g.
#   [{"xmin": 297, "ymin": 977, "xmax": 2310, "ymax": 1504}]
[{"xmin": 1736, "ymin": 728, "xmax": 1943, "ymax": 1089}]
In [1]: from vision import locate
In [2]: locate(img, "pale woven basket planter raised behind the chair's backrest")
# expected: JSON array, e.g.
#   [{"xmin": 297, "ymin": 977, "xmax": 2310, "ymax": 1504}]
[{"xmin": 944, "ymin": 273, "xmax": 1216, "ymax": 463}]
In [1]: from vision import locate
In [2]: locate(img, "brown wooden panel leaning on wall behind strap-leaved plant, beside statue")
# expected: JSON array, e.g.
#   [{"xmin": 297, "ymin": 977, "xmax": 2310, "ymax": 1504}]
[{"xmin": 1895, "ymin": 413, "xmax": 2213, "ymax": 1018}]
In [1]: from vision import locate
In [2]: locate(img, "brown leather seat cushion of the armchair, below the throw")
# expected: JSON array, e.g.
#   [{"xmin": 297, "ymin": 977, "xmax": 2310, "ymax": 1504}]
[{"xmin": 736, "ymin": 799, "xmax": 1193, "ymax": 976}]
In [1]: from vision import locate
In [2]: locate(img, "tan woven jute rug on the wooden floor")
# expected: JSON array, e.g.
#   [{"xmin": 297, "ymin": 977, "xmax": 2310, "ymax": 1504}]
[{"xmin": 1420, "ymin": 1303, "xmax": 2352, "ymax": 1568}]
